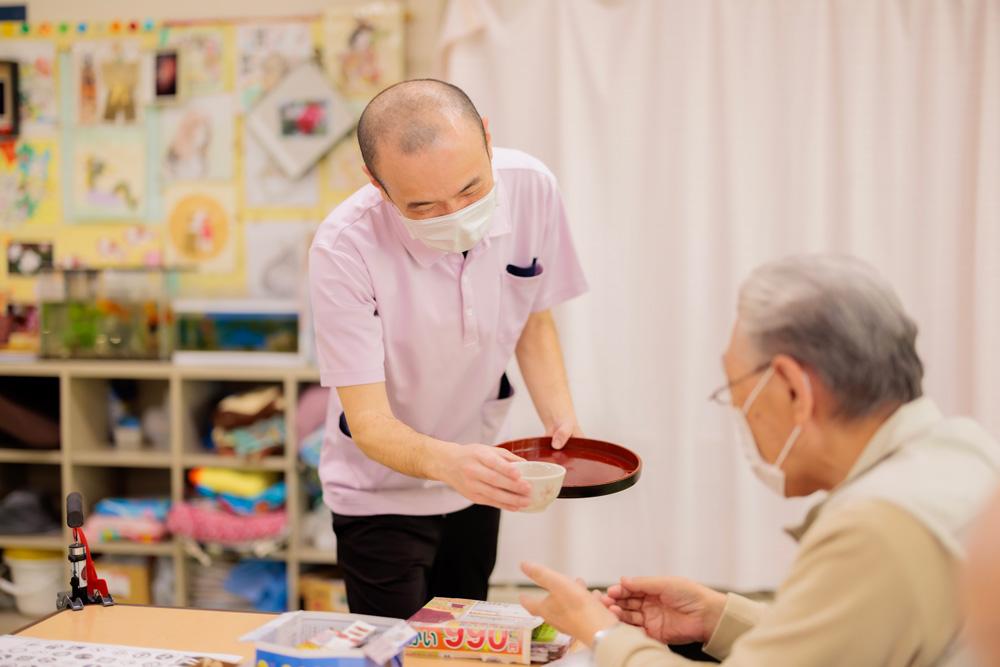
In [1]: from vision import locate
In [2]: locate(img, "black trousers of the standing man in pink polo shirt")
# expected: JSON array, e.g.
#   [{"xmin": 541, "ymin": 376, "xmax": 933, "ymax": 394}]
[{"xmin": 333, "ymin": 505, "xmax": 500, "ymax": 618}]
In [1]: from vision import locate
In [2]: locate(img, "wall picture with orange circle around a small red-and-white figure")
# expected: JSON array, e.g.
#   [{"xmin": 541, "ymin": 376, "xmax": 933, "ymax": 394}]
[{"xmin": 166, "ymin": 186, "xmax": 239, "ymax": 273}]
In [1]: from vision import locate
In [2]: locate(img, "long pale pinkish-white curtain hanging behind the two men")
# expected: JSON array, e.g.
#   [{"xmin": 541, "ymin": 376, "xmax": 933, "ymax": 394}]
[{"xmin": 442, "ymin": 0, "xmax": 1000, "ymax": 589}]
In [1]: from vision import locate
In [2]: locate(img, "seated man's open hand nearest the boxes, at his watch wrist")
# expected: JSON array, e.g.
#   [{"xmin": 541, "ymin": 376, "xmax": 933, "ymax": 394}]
[{"xmin": 521, "ymin": 563, "xmax": 618, "ymax": 646}]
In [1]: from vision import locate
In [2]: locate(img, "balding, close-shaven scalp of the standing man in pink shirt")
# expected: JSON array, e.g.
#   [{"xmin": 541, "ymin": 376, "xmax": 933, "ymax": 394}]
[{"xmin": 358, "ymin": 79, "xmax": 486, "ymax": 187}]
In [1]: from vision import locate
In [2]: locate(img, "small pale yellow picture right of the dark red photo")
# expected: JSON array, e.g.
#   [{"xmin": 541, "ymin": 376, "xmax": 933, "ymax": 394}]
[{"xmin": 168, "ymin": 26, "xmax": 232, "ymax": 96}]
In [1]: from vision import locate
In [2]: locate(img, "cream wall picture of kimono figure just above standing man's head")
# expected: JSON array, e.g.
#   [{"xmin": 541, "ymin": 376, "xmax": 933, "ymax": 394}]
[{"xmin": 323, "ymin": 1, "xmax": 405, "ymax": 100}]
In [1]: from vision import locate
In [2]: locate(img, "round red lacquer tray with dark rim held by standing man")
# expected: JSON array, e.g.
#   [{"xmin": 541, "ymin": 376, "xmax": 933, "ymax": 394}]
[{"xmin": 497, "ymin": 438, "xmax": 642, "ymax": 498}]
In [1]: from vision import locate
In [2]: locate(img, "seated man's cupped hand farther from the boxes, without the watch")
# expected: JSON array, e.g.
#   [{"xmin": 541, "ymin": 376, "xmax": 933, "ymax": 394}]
[{"xmin": 603, "ymin": 577, "xmax": 726, "ymax": 644}]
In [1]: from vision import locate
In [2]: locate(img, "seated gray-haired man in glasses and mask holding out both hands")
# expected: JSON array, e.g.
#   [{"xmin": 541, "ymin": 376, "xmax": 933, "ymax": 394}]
[{"xmin": 523, "ymin": 256, "xmax": 1000, "ymax": 667}]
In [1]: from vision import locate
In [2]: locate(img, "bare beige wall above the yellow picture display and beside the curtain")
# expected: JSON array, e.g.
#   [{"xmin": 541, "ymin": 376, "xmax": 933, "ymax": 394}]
[{"xmin": 25, "ymin": 0, "xmax": 447, "ymax": 77}]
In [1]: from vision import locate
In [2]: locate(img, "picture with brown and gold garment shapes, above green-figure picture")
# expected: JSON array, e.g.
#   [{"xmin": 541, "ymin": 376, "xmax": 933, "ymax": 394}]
[{"xmin": 73, "ymin": 39, "xmax": 153, "ymax": 125}]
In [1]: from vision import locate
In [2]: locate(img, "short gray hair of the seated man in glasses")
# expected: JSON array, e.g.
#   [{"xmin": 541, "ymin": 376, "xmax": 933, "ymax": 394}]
[{"xmin": 738, "ymin": 255, "xmax": 924, "ymax": 420}]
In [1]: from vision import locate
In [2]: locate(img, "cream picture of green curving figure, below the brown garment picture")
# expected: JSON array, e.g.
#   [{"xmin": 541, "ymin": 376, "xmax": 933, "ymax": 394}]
[{"xmin": 70, "ymin": 128, "xmax": 146, "ymax": 220}]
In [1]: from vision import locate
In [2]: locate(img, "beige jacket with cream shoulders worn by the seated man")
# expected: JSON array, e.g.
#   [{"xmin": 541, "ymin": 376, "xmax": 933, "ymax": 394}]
[{"xmin": 595, "ymin": 399, "xmax": 1000, "ymax": 667}]
